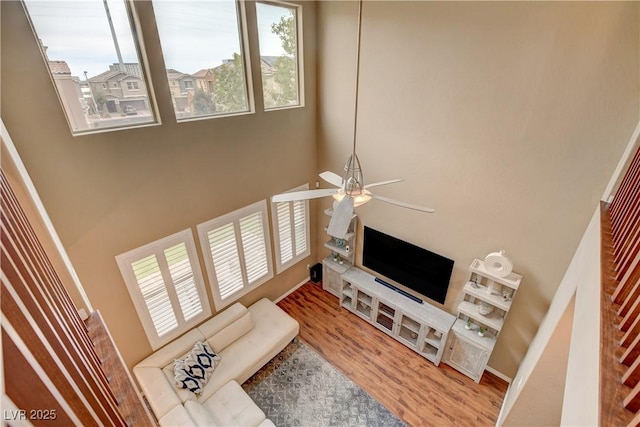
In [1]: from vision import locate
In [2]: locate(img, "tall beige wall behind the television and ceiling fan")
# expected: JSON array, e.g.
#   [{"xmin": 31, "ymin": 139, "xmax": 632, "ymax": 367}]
[{"xmin": 318, "ymin": 1, "xmax": 640, "ymax": 377}]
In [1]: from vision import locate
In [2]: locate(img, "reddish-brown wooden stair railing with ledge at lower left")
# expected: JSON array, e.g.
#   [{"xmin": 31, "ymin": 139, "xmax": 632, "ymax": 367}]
[{"xmin": 0, "ymin": 172, "xmax": 155, "ymax": 427}]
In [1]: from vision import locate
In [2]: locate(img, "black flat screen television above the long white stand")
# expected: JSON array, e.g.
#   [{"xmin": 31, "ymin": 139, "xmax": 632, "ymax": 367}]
[{"xmin": 362, "ymin": 226, "xmax": 454, "ymax": 304}]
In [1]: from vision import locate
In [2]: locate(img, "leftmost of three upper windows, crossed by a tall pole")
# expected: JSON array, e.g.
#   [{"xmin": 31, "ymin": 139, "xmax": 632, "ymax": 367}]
[{"xmin": 23, "ymin": 0, "xmax": 158, "ymax": 135}]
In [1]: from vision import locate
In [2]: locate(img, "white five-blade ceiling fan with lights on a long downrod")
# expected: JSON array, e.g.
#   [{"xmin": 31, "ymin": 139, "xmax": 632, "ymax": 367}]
[{"xmin": 272, "ymin": 0, "xmax": 435, "ymax": 238}]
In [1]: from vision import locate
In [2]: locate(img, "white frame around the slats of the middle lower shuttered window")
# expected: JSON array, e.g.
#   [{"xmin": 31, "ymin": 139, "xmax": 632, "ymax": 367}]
[{"xmin": 197, "ymin": 200, "xmax": 273, "ymax": 311}]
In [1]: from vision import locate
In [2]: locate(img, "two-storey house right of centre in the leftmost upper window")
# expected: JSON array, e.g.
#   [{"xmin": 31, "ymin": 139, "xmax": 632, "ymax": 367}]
[{"xmin": 89, "ymin": 70, "xmax": 149, "ymax": 113}]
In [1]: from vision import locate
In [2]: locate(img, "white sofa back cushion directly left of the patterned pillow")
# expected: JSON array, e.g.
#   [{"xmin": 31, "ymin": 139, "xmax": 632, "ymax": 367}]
[{"xmin": 133, "ymin": 366, "xmax": 182, "ymax": 418}]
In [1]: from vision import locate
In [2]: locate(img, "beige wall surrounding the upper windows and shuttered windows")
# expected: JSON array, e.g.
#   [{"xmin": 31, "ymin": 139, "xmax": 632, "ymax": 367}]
[{"xmin": 0, "ymin": 2, "xmax": 317, "ymax": 372}]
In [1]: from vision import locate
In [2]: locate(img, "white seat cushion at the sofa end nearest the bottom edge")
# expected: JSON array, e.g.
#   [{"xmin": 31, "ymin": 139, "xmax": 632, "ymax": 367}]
[{"xmin": 202, "ymin": 381, "xmax": 267, "ymax": 426}]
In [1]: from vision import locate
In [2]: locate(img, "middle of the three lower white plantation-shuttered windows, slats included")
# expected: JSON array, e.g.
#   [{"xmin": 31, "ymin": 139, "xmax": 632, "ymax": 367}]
[{"xmin": 198, "ymin": 201, "xmax": 273, "ymax": 310}]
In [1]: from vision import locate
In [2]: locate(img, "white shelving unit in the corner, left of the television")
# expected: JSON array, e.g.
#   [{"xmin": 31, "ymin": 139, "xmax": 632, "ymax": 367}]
[{"xmin": 322, "ymin": 209, "xmax": 358, "ymax": 297}]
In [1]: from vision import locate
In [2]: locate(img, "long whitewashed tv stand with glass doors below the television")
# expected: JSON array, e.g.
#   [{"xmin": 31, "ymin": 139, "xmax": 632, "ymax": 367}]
[{"xmin": 339, "ymin": 267, "xmax": 456, "ymax": 366}]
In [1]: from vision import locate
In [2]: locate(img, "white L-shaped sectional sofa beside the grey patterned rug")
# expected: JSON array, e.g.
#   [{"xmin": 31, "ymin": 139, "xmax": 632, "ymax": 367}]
[{"xmin": 133, "ymin": 298, "xmax": 299, "ymax": 426}]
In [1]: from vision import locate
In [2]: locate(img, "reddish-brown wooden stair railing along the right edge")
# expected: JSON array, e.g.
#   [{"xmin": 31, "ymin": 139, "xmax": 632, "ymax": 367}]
[{"xmin": 599, "ymin": 148, "xmax": 640, "ymax": 426}]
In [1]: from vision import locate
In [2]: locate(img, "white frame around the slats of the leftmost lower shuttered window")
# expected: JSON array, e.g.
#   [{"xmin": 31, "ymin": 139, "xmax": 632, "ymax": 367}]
[{"xmin": 116, "ymin": 229, "xmax": 211, "ymax": 350}]
